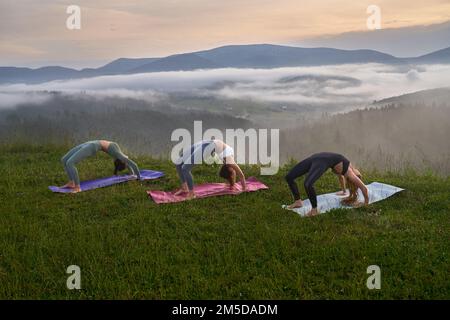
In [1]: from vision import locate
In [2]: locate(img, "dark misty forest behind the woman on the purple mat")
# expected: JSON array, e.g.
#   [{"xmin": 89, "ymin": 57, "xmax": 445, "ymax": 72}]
[{"xmin": 0, "ymin": 94, "xmax": 252, "ymax": 157}]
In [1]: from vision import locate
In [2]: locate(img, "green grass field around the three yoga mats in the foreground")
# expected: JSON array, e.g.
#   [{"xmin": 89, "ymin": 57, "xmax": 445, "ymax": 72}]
[{"xmin": 0, "ymin": 145, "xmax": 450, "ymax": 299}]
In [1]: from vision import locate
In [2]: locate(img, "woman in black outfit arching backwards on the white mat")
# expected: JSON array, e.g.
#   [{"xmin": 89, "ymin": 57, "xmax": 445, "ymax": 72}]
[{"xmin": 286, "ymin": 152, "xmax": 369, "ymax": 216}]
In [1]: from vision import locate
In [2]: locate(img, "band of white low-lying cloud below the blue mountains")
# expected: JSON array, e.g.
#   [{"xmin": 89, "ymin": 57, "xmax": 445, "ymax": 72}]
[{"xmin": 0, "ymin": 63, "xmax": 450, "ymax": 108}]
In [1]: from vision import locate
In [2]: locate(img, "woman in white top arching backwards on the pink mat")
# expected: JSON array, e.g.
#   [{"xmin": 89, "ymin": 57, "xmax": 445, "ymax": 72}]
[{"xmin": 175, "ymin": 140, "xmax": 247, "ymax": 199}]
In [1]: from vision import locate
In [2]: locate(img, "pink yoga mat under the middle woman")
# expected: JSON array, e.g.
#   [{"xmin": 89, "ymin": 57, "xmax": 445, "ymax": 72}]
[{"xmin": 147, "ymin": 177, "xmax": 269, "ymax": 204}]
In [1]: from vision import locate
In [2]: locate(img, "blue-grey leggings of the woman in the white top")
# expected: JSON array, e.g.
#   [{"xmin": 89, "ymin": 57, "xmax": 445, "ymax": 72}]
[{"xmin": 176, "ymin": 141, "xmax": 215, "ymax": 191}]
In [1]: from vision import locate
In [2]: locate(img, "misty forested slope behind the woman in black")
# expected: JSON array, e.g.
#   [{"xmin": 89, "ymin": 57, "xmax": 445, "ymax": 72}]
[{"xmin": 280, "ymin": 103, "xmax": 450, "ymax": 175}]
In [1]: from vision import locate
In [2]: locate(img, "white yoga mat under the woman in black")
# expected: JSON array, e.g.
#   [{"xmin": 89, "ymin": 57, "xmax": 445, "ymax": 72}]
[{"xmin": 282, "ymin": 182, "xmax": 404, "ymax": 217}]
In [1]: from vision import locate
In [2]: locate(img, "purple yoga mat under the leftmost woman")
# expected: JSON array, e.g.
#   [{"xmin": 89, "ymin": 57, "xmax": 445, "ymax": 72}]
[{"xmin": 48, "ymin": 170, "xmax": 164, "ymax": 193}]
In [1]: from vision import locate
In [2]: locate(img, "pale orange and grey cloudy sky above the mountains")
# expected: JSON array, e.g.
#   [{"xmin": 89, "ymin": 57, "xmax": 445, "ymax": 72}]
[{"xmin": 0, "ymin": 0, "xmax": 450, "ymax": 67}]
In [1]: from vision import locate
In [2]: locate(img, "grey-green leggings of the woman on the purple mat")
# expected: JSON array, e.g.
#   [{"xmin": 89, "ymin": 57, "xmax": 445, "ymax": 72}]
[{"xmin": 61, "ymin": 141, "xmax": 101, "ymax": 185}]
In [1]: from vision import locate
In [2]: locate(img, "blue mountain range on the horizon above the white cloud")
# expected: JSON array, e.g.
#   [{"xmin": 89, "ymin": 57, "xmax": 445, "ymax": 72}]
[{"xmin": 0, "ymin": 44, "xmax": 450, "ymax": 84}]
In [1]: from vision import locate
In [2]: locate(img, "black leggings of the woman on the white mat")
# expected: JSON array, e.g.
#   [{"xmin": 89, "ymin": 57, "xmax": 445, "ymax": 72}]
[{"xmin": 286, "ymin": 158, "xmax": 329, "ymax": 208}]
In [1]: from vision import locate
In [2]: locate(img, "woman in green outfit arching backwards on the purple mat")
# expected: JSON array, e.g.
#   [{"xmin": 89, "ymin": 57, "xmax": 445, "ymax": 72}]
[{"xmin": 61, "ymin": 140, "xmax": 141, "ymax": 193}]
